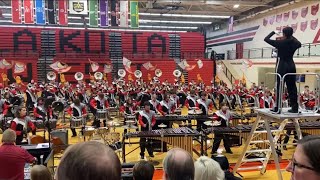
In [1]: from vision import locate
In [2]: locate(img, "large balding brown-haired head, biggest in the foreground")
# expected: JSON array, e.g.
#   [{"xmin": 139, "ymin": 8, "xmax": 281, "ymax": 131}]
[{"xmin": 57, "ymin": 141, "xmax": 121, "ymax": 180}]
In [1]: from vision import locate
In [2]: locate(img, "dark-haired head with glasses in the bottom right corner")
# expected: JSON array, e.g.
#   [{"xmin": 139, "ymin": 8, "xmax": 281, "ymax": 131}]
[{"xmin": 286, "ymin": 136, "xmax": 320, "ymax": 180}]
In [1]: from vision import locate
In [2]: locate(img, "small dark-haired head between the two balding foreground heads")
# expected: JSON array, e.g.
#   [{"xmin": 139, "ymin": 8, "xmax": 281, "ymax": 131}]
[{"xmin": 133, "ymin": 161, "xmax": 154, "ymax": 180}]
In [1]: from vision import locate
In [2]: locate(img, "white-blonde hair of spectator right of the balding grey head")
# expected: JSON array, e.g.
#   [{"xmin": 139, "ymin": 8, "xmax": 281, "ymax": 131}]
[{"xmin": 194, "ymin": 156, "xmax": 224, "ymax": 180}]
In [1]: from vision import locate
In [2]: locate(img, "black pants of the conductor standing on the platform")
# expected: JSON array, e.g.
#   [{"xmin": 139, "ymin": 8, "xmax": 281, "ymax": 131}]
[{"xmin": 275, "ymin": 60, "xmax": 299, "ymax": 110}]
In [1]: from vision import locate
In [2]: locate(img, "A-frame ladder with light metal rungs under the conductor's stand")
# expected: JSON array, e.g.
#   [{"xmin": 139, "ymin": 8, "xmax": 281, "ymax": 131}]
[{"xmin": 233, "ymin": 116, "xmax": 301, "ymax": 180}]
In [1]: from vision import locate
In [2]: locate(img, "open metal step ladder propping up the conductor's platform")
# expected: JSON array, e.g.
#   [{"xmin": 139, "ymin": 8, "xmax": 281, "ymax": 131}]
[{"xmin": 233, "ymin": 109, "xmax": 302, "ymax": 180}]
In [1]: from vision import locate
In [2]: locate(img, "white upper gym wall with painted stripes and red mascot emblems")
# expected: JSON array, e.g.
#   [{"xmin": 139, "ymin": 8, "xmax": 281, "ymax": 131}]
[{"xmin": 206, "ymin": 1, "xmax": 320, "ymax": 59}]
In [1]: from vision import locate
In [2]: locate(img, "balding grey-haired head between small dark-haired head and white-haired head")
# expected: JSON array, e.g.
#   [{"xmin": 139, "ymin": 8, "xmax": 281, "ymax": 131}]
[{"xmin": 163, "ymin": 148, "xmax": 194, "ymax": 180}]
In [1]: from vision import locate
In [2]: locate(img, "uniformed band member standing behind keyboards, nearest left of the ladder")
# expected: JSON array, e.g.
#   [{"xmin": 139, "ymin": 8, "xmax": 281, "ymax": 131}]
[{"xmin": 211, "ymin": 103, "xmax": 232, "ymax": 154}]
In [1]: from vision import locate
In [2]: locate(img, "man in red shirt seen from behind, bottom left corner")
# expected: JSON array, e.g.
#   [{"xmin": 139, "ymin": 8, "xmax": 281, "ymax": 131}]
[{"xmin": 0, "ymin": 129, "xmax": 36, "ymax": 180}]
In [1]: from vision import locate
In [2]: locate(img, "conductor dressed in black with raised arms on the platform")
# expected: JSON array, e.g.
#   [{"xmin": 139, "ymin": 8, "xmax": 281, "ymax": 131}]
[{"xmin": 264, "ymin": 27, "xmax": 301, "ymax": 113}]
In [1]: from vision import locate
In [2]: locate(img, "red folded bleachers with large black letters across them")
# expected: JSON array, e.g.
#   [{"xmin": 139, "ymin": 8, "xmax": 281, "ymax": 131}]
[{"xmin": 0, "ymin": 27, "xmax": 213, "ymax": 83}]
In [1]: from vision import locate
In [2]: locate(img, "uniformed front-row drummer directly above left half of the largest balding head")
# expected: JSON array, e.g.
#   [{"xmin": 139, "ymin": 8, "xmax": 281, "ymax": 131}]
[{"xmin": 67, "ymin": 99, "xmax": 87, "ymax": 137}]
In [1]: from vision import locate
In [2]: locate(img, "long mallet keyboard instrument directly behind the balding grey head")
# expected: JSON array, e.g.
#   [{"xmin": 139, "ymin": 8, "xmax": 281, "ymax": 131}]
[{"xmin": 122, "ymin": 127, "xmax": 203, "ymax": 162}]
